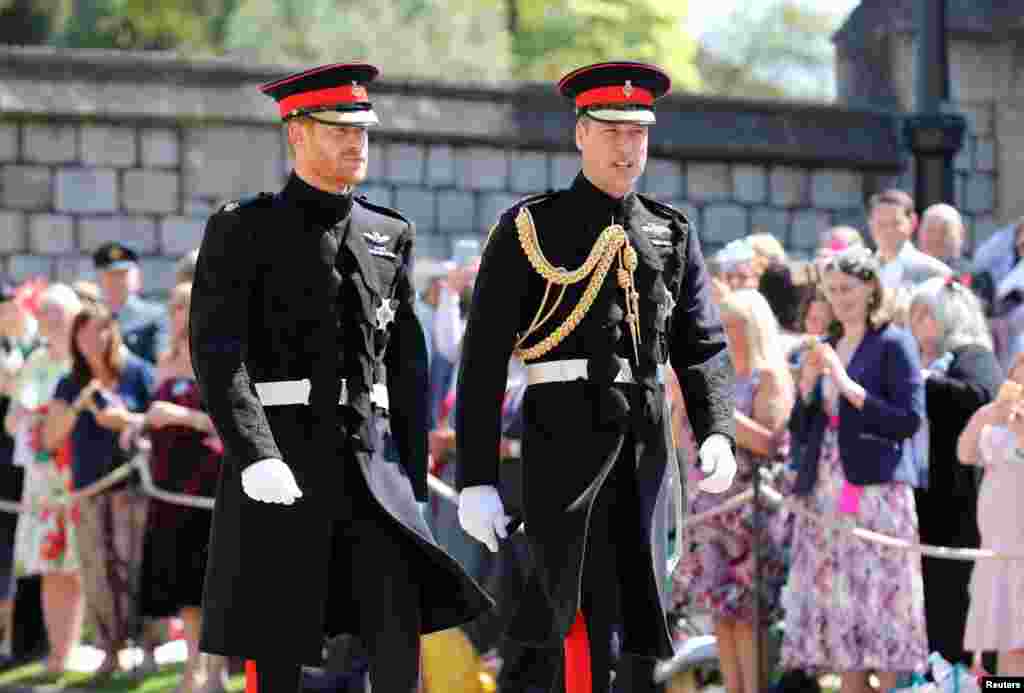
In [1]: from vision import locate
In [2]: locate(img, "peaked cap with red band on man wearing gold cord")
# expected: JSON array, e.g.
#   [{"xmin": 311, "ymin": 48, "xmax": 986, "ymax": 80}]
[{"xmin": 558, "ymin": 60, "xmax": 672, "ymax": 125}]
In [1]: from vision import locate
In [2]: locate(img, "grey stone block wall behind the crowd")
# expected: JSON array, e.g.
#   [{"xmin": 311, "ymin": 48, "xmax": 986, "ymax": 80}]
[{"xmin": 0, "ymin": 42, "xmax": 921, "ymax": 293}]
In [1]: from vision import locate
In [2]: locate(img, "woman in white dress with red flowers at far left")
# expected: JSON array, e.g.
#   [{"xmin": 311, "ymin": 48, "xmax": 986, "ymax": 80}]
[{"xmin": 5, "ymin": 284, "xmax": 84, "ymax": 674}]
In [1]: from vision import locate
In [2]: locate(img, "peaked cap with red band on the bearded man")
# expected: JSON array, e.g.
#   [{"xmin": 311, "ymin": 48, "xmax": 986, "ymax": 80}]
[{"xmin": 259, "ymin": 62, "xmax": 380, "ymax": 126}]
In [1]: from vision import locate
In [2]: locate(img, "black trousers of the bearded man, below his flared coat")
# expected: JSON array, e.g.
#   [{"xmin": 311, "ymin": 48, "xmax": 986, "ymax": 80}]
[{"xmin": 256, "ymin": 463, "xmax": 420, "ymax": 693}]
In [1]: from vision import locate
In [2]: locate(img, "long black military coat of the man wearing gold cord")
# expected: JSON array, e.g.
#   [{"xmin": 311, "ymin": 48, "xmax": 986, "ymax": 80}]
[{"xmin": 456, "ymin": 174, "xmax": 733, "ymax": 657}]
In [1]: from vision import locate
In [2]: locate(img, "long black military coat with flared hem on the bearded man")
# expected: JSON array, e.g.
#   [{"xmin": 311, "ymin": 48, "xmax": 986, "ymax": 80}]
[{"xmin": 190, "ymin": 175, "xmax": 492, "ymax": 664}]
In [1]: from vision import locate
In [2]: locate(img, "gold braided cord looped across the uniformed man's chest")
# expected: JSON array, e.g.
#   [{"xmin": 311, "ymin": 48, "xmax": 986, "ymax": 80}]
[{"xmin": 514, "ymin": 207, "xmax": 635, "ymax": 361}]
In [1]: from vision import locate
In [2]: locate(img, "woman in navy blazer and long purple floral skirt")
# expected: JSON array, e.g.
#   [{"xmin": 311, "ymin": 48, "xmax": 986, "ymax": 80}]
[{"xmin": 781, "ymin": 249, "xmax": 928, "ymax": 693}]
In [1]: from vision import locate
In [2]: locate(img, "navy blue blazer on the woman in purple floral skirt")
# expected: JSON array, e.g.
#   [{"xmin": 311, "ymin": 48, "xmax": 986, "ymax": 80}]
[{"xmin": 790, "ymin": 324, "xmax": 927, "ymax": 495}]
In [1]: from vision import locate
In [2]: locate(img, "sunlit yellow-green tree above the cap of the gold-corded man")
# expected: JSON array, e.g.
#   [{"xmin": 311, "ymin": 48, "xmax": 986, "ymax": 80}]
[{"xmin": 504, "ymin": 0, "xmax": 700, "ymax": 90}]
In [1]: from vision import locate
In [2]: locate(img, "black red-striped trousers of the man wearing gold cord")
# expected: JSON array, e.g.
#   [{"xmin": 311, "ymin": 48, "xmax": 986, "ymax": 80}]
[{"xmin": 551, "ymin": 446, "xmax": 664, "ymax": 693}]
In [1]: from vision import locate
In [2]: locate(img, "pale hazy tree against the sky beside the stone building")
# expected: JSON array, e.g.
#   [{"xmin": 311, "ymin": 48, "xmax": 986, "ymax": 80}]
[{"xmin": 696, "ymin": 0, "xmax": 842, "ymax": 100}]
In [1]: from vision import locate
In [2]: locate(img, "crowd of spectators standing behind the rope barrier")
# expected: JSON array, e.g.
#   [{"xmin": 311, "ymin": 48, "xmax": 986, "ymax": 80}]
[{"xmin": 0, "ymin": 185, "xmax": 1024, "ymax": 693}]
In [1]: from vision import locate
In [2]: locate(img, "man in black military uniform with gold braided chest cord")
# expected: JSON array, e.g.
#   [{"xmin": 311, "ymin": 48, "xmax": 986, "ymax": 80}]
[{"xmin": 456, "ymin": 62, "xmax": 735, "ymax": 693}]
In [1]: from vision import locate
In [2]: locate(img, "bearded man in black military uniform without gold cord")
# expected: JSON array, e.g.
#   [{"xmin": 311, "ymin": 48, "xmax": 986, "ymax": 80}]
[{"xmin": 190, "ymin": 64, "xmax": 492, "ymax": 693}]
